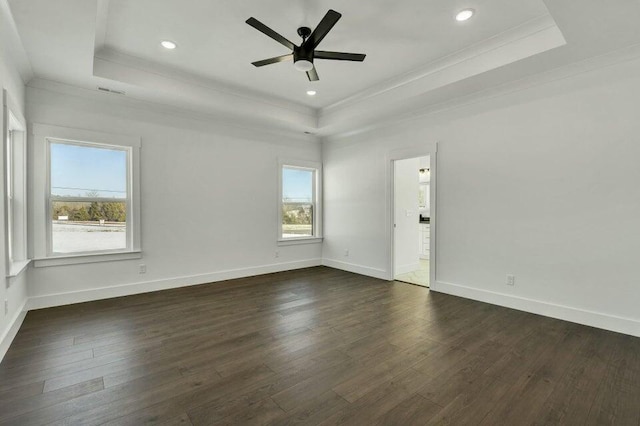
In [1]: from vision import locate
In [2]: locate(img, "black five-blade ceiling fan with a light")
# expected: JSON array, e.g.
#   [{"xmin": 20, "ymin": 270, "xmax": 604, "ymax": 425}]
[{"xmin": 247, "ymin": 9, "xmax": 366, "ymax": 81}]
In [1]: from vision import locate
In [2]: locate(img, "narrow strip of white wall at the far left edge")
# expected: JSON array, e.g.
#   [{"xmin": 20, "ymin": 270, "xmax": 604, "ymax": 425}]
[{"xmin": 0, "ymin": 3, "xmax": 27, "ymax": 360}]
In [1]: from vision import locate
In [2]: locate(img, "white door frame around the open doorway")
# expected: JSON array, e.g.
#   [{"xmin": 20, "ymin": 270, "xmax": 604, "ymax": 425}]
[{"xmin": 386, "ymin": 142, "xmax": 438, "ymax": 290}]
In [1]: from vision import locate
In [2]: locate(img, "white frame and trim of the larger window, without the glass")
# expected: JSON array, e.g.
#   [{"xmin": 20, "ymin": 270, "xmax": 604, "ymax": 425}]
[{"xmin": 33, "ymin": 124, "xmax": 142, "ymax": 267}]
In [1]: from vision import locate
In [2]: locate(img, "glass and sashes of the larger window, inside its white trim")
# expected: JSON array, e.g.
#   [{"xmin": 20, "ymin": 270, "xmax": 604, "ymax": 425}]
[{"xmin": 49, "ymin": 139, "xmax": 131, "ymax": 255}]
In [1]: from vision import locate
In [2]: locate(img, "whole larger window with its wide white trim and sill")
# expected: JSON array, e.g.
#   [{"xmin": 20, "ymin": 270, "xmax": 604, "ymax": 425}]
[{"xmin": 34, "ymin": 124, "xmax": 140, "ymax": 267}]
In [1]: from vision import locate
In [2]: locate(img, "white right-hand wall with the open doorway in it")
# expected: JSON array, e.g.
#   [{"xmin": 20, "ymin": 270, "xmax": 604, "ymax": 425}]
[{"xmin": 323, "ymin": 53, "xmax": 640, "ymax": 335}]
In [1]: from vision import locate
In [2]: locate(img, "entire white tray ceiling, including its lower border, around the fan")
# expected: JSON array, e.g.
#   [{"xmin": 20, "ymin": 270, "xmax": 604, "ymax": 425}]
[{"xmin": 6, "ymin": 0, "xmax": 640, "ymax": 134}]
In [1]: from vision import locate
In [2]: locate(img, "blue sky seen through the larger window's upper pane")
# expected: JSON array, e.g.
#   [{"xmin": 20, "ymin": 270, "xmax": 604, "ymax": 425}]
[{"xmin": 51, "ymin": 143, "xmax": 127, "ymax": 198}]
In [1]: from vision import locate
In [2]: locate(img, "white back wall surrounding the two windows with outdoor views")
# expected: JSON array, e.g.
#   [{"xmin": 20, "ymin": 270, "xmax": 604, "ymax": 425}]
[{"xmin": 27, "ymin": 87, "xmax": 322, "ymax": 307}]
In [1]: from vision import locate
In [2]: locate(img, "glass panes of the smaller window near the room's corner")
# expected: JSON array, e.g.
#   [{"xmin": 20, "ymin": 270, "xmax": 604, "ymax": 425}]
[{"xmin": 282, "ymin": 167, "xmax": 315, "ymax": 238}]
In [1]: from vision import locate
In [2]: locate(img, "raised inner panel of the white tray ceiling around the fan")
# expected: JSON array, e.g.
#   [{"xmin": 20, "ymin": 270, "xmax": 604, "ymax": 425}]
[{"xmin": 104, "ymin": 0, "xmax": 548, "ymax": 107}]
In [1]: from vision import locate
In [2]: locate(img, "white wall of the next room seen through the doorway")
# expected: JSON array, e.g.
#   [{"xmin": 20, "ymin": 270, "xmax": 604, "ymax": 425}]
[{"xmin": 393, "ymin": 158, "xmax": 420, "ymax": 275}]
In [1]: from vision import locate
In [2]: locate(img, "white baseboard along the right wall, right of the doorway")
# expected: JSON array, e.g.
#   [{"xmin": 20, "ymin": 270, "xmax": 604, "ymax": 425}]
[{"xmin": 431, "ymin": 281, "xmax": 640, "ymax": 337}]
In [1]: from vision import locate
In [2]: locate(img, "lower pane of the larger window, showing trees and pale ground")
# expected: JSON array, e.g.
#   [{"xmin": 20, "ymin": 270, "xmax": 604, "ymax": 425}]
[{"xmin": 51, "ymin": 201, "xmax": 127, "ymax": 253}]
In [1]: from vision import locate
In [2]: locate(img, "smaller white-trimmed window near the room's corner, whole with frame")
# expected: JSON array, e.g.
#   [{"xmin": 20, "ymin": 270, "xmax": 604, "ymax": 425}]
[{"xmin": 278, "ymin": 161, "xmax": 322, "ymax": 241}]
